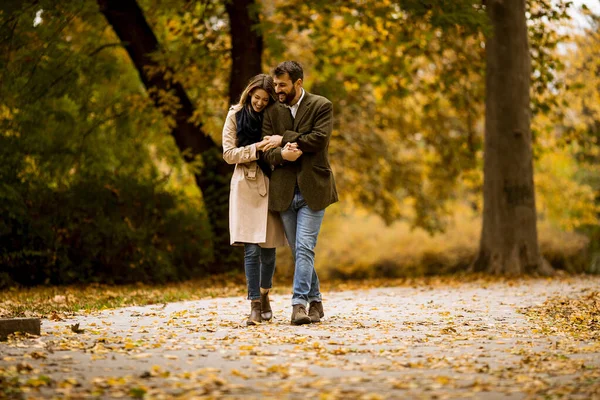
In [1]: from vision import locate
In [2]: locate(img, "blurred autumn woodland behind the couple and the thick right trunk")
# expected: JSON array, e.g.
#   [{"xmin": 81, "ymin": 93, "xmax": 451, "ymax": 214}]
[{"xmin": 0, "ymin": 0, "xmax": 600, "ymax": 285}]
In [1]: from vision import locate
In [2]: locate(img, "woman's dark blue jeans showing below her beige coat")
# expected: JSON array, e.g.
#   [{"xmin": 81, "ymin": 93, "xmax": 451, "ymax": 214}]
[{"xmin": 244, "ymin": 243, "xmax": 275, "ymax": 300}]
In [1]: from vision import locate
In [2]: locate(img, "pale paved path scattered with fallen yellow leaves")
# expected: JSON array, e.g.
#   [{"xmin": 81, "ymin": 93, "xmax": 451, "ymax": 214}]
[{"xmin": 0, "ymin": 277, "xmax": 600, "ymax": 399}]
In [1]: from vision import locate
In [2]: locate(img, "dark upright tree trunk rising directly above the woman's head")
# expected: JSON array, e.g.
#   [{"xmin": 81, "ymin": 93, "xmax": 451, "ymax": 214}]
[{"xmin": 225, "ymin": 0, "xmax": 263, "ymax": 104}]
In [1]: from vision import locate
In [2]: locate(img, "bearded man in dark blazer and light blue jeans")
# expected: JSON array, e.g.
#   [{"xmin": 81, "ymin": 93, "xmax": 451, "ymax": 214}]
[{"xmin": 263, "ymin": 61, "xmax": 338, "ymax": 325}]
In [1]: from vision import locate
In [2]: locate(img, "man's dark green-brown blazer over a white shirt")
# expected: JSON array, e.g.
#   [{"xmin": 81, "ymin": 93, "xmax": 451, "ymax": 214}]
[{"xmin": 262, "ymin": 91, "xmax": 338, "ymax": 211}]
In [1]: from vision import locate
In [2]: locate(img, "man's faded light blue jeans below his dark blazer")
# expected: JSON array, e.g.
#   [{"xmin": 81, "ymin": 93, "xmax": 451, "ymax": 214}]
[{"xmin": 281, "ymin": 187, "xmax": 325, "ymax": 307}]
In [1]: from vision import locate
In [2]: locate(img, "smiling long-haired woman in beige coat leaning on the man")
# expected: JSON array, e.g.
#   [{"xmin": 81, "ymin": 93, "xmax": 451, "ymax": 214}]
[{"xmin": 223, "ymin": 74, "xmax": 286, "ymax": 325}]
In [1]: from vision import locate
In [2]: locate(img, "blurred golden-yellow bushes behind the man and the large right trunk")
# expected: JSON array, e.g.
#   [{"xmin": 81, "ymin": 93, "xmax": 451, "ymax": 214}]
[{"xmin": 296, "ymin": 205, "xmax": 592, "ymax": 279}]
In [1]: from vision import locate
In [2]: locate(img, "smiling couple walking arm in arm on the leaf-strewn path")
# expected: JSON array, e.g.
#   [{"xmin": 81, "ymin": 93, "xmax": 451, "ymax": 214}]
[{"xmin": 223, "ymin": 61, "xmax": 338, "ymax": 325}]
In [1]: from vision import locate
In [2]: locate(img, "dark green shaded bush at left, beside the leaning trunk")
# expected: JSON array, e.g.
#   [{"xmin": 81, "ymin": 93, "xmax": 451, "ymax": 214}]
[{"xmin": 0, "ymin": 177, "xmax": 212, "ymax": 287}]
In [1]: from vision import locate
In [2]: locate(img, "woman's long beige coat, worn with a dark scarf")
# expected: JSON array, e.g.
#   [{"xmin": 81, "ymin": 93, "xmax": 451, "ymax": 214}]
[{"xmin": 223, "ymin": 105, "xmax": 287, "ymax": 248}]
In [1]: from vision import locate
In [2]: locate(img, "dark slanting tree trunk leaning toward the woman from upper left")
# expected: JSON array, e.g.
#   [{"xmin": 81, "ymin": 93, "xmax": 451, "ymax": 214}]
[{"xmin": 98, "ymin": 0, "xmax": 242, "ymax": 272}]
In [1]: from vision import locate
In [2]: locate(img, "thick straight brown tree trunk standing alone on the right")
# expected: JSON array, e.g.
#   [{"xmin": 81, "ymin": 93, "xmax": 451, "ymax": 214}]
[{"xmin": 473, "ymin": 0, "xmax": 552, "ymax": 275}]
